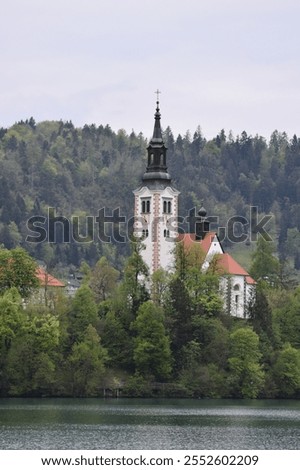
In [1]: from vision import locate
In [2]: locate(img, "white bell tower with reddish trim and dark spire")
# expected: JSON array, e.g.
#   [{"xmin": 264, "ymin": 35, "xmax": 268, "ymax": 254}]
[{"xmin": 133, "ymin": 101, "xmax": 179, "ymax": 274}]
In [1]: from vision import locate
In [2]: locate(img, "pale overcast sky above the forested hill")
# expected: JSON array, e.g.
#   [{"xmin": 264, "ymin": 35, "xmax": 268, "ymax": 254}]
[{"xmin": 0, "ymin": 0, "xmax": 300, "ymax": 138}]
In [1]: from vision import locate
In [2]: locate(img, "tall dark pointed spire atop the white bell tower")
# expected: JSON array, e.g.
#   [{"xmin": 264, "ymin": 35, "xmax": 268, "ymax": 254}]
[{"xmin": 143, "ymin": 90, "xmax": 171, "ymax": 183}]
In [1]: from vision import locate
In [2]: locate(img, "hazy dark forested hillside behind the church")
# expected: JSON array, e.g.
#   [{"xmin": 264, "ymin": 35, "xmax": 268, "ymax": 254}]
[{"xmin": 0, "ymin": 118, "xmax": 300, "ymax": 272}]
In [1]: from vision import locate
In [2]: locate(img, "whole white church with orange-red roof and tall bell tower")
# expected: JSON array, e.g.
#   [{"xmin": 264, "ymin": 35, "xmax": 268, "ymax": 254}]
[{"xmin": 133, "ymin": 101, "xmax": 255, "ymax": 318}]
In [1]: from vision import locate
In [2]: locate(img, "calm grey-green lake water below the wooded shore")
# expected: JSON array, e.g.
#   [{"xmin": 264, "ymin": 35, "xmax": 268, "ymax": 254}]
[{"xmin": 0, "ymin": 398, "xmax": 300, "ymax": 450}]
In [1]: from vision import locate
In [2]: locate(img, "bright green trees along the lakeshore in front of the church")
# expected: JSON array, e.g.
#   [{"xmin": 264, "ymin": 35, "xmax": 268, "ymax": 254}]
[{"xmin": 0, "ymin": 238, "xmax": 300, "ymax": 398}]
